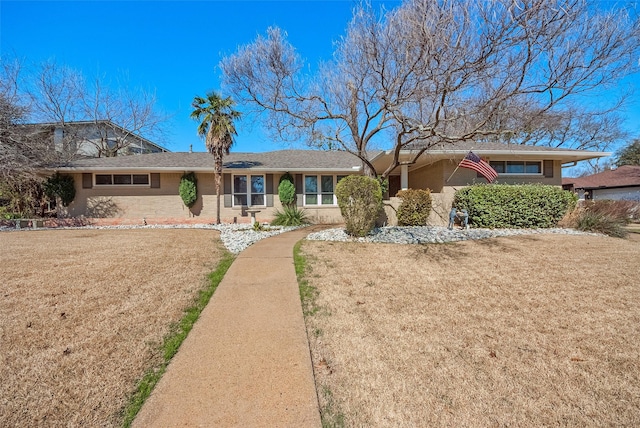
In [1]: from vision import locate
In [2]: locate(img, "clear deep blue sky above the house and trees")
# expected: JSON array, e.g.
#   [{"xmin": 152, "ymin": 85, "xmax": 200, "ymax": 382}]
[{"xmin": 0, "ymin": 0, "xmax": 640, "ymax": 158}]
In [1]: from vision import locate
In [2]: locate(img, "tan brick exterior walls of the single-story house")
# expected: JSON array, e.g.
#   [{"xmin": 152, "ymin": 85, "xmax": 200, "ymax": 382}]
[{"xmin": 60, "ymin": 159, "xmax": 562, "ymax": 225}]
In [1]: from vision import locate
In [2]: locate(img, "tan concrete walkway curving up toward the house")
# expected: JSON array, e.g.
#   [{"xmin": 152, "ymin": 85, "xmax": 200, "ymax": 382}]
[{"xmin": 133, "ymin": 227, "xmax": 321, "ymax": 428}]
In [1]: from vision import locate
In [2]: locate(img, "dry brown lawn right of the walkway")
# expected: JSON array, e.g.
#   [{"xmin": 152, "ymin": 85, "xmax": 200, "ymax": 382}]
[{"xmin": 302, "ymin": 235, "xmax": 640, "ymax": 427}]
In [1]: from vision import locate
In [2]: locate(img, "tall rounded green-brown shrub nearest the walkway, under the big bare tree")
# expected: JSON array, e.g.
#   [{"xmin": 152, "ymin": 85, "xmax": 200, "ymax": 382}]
[{"xmin": 336, "ymin": 175, "xmax": 382, "ymax": 236}]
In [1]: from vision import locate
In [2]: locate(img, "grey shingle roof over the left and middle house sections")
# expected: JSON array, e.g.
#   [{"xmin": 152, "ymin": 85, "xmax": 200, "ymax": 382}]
[{"xmin": 59, "ymin": 150, "xmax": 370, "ymax": 171}]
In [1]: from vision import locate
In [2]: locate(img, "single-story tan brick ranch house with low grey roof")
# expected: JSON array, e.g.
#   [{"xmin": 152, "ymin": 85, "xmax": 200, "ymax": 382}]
[{"xmin": 51, "ymin": 143, "xmax": 608, "ymax": 224}]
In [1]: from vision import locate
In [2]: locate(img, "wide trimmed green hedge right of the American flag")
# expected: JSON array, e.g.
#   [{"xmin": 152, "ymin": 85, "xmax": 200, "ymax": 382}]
[{"xmin": 453, "ymin": 184, "xmax": 577, "ymax": 228}]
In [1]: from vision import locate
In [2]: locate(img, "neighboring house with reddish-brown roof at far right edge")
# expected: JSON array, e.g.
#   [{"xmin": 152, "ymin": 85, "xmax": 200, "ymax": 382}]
[{"xmin": 562, "ymin": 165, "xmax": 640, "ymax": 201}]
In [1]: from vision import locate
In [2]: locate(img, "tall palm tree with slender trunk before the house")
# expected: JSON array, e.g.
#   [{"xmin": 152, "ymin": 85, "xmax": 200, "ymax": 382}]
[{"xmin": 190, "ymin": 92, "xmax": 240, "ymax": 224}]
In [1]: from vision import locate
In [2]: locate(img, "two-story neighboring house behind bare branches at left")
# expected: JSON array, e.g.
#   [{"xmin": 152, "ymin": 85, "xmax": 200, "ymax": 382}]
[{"xmin": 19, "ymin": 120, "xmax": 169, "ymax": 157}]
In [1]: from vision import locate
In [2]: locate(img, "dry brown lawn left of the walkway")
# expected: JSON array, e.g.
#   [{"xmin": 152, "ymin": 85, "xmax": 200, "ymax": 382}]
[{"xmin": 0, "ymin": 229, "xmax": 221, "ymax": 427}]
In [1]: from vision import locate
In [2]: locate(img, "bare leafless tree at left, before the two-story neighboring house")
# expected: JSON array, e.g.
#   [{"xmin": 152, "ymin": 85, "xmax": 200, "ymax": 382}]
[{"xmin": 28, "ymin": 61, "xmax": 167, "ymax": 157}]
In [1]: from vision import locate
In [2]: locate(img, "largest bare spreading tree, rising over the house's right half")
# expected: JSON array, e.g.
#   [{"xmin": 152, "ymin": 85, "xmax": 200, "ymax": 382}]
[{"xmin": 220, "ymin": 0, "xmax": 640, "ymax": 177}]
